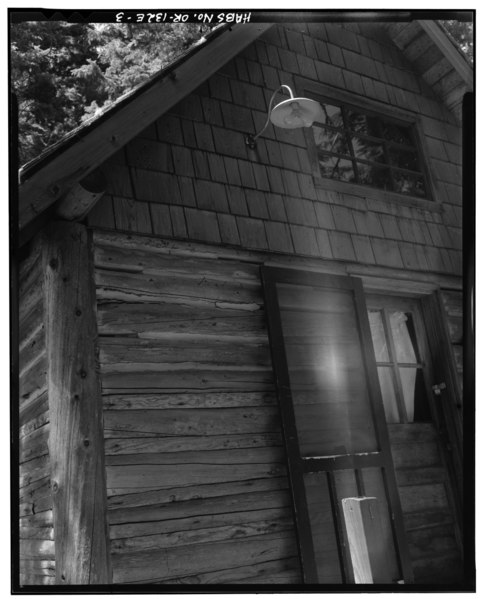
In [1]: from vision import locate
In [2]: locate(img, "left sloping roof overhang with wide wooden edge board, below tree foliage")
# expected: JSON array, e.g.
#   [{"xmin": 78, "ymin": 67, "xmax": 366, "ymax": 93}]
[{"xmin": 18, "ymin": 23, "xmax": 272, "ymax": 230}]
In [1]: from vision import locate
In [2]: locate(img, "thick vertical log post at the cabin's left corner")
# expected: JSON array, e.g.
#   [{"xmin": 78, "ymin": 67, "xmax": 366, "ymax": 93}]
[{"xmin": 43, "ymin": 222, "xmax": 111, "ymax": 584}]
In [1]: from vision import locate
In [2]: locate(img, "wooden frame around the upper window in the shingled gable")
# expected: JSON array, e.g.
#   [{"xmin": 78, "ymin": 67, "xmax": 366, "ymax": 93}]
[{"xmin": 294, "ymin": 76, "xmax": 442, "ymax": 212}]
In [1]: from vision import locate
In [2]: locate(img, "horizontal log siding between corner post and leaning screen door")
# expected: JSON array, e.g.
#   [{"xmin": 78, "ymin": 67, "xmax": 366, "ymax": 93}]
[{"xmin": 94, "ymin": 234, "xmax": 300, "ymax": 584}]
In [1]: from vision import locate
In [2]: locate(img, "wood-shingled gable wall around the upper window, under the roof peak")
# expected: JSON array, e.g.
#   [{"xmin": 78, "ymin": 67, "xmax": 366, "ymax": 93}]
[{"xmin": 89, "ymin": 23, "xmax": 462, "ymax": 275}]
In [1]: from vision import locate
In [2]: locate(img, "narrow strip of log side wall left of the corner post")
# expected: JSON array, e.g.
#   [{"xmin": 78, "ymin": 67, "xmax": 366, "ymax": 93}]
[{"xmin": 19, "ymin": 251, "xmax": 55, "ymax": 584}]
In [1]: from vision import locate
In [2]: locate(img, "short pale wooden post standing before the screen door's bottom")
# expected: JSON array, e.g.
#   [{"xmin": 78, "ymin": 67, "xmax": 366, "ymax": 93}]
[{"xmin": 342, "ymin": 497, "xmax": 393, "ymax": 584}]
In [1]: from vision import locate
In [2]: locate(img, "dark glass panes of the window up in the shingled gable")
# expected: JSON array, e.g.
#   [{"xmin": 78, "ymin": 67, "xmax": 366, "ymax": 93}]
[{"xmin": 313, "ymin": 100, "xmax": 428, "ymax": 198}]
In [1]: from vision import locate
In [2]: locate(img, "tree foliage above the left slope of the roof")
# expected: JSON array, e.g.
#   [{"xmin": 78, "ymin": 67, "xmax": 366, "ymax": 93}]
[{"xmin": 10, "ymin": 21, "xmax": 208, "ymax": 164}]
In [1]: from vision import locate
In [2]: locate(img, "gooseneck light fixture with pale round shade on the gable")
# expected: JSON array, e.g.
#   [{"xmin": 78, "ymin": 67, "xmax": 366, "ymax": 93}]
[{"xmin": 245, "ymin": 85, "xmax": 321, "ymax": 150}]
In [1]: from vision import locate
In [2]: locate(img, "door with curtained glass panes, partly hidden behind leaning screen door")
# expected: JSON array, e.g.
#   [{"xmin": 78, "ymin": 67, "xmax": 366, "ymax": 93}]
[{"xmin": 367, "ymin": 296, "xmax": 463, "ymax": 583}]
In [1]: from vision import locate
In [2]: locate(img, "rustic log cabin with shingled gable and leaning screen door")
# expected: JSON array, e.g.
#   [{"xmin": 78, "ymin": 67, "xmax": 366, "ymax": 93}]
[{"xmin": 16, "ymin": 20, "xmax": 473, "ymax": 590}]
